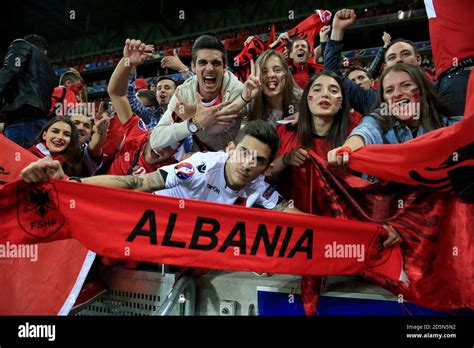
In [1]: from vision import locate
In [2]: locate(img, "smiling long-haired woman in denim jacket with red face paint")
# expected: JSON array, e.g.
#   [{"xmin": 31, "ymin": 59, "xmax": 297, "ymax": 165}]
[{"xmin": 328, "ymin": 63, "xmax": 462, "ymax": 166}]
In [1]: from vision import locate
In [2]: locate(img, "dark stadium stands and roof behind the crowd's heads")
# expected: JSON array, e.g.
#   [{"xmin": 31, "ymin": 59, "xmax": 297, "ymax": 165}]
[{"xmin": 0, "ymin": 0, "xmax": 432, "ymax": 101}]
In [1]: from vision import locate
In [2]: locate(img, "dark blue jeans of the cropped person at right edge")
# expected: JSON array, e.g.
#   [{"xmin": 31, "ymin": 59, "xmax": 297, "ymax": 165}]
[{"xmin": 438, "ymin": 68, "xmax": 472, "ymax": 116}]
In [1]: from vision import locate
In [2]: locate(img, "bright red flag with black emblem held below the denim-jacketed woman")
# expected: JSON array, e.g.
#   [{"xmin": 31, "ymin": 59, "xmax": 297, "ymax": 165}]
[{"xmin": 349, "ymin": 114, "xmax": 474, "ymax": 191}]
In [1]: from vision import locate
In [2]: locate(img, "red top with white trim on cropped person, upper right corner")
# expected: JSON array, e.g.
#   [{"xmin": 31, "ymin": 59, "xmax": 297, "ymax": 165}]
[{"xmin": 425, "ymin": 0, "xmax": 474, "ymax": 78}]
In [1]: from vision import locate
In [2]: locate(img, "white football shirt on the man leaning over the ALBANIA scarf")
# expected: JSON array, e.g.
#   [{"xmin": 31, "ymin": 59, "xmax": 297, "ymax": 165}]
[{"xmin": 154, "ymin": 151, "xmax": 280, "ymax": 209}]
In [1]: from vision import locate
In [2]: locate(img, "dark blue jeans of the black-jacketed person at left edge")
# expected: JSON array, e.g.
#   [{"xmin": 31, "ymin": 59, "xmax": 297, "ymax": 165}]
[{"xmin": 3, "ymin": 118, "xmax": 48, "ymax": 149}]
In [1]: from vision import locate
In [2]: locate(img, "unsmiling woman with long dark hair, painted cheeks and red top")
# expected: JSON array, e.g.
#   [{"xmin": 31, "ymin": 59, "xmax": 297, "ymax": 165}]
[{"xmin": 271, "ymin": 71, "xmax": 401, "ymax": 247}]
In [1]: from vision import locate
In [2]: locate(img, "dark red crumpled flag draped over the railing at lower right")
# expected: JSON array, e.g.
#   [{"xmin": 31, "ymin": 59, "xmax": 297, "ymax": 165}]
[{"xmin": 302, "ymin": 153, "xmax": 474, "ymax": 310}]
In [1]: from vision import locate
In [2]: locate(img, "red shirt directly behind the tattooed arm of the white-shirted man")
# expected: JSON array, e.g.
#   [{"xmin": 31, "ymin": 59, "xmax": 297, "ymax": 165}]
[{"xmin": 107, "ymin": 115, "xmax": 176, "ymax": 175}]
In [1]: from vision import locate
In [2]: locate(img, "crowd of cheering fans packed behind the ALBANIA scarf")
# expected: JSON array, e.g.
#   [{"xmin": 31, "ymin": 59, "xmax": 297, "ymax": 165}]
[{"xmin": 0, "ymin": 3, "xmax": 470, "ymax": 312}]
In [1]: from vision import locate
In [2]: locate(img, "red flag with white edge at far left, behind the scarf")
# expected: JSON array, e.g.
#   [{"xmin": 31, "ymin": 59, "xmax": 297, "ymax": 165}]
[{"xmin": 0, "ymin": 134, "xmax": 95, "ymax": 315}]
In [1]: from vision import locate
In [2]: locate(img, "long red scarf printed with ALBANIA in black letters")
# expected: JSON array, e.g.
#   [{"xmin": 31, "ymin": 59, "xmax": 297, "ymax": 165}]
[{"xmin": 0, "ymin": 180, "xmax": 402, "ymax": 281}]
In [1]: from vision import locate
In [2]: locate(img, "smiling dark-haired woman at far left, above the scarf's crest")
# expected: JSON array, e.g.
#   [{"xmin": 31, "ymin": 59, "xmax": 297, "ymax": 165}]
[{"xmin": 28, "ymin": 117, "xmax": 82, "ymax": 176}]
